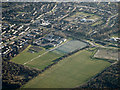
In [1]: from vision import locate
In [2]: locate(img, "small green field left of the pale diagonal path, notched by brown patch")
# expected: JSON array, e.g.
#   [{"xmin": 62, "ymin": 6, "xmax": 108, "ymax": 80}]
[{"xmin": 11, "ymin": 45, "xmax": 46, "ymax": 64}]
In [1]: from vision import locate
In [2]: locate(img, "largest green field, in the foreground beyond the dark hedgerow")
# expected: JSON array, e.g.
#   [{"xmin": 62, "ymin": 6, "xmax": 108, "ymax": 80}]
[{"xmin": 22, "ymin": 50, "xmax": 110, "ymax": 88}]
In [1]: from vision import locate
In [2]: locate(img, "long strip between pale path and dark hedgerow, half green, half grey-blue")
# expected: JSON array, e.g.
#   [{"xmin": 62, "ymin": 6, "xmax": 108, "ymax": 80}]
[{"xmin": 26, "ymin": 40, "xmax": 86, "ymax": 70}]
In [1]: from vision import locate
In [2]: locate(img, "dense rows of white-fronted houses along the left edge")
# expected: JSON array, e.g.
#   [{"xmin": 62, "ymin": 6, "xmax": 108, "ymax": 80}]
[{"xmin": 0, "ymin": 23, "xmax": 30, "ymax": 58}]
